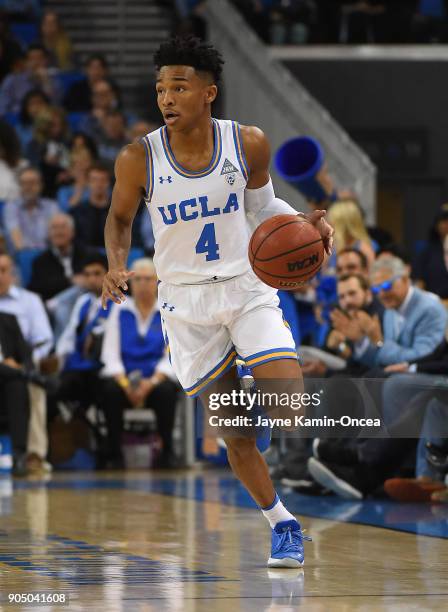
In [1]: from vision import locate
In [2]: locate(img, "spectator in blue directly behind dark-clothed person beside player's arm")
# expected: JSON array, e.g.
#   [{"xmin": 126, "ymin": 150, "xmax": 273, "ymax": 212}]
[{"xmin": 57, "ymin": 146, "xmax": 95, "ymax": 211}]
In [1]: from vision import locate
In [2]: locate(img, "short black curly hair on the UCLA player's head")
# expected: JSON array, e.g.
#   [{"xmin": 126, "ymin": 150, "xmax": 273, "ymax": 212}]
[{"xmin": 154, "ymin": 36, "xmax": 224, "ymax": 83}]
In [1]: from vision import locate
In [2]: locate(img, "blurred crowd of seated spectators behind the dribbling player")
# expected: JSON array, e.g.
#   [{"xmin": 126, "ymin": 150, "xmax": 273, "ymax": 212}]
[{"xmin": 0, "ymin": 0, "xmax": 448, "ymax": 506}]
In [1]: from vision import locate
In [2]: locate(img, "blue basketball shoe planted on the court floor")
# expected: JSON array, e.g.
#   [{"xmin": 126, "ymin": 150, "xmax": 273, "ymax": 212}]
[{"xmin": 268, "ymin": 520, "xmax": 311, "ymax": 567}]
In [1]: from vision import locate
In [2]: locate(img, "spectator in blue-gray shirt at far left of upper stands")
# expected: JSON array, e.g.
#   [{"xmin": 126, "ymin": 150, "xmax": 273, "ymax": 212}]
[{"xmin": 0, "ymin": 43, "xmax": 61, "ymax": 115}]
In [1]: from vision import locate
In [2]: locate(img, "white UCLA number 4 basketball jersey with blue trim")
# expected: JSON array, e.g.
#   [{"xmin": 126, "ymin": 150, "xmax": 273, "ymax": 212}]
[{"xmin": 142, "ymin": 119, "xmax": 250, "ymax": 284}]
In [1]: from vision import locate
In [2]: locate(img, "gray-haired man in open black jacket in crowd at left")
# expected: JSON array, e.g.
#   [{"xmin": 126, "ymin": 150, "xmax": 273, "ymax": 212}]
[{"xmin": 28, "ymin": 213, "xmax": 86, "ymax": 302}]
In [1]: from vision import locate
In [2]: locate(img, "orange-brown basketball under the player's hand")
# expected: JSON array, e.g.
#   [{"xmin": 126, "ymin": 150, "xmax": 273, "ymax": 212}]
[{"xmin": 249, "ymin": 215, "xmax": 325, "ymax": 291}]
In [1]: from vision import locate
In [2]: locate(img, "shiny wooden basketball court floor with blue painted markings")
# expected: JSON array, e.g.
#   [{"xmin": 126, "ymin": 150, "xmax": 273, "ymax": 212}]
[{"xmin": 0, "ymin": 469, "xmax": 448, "ymax": 612}]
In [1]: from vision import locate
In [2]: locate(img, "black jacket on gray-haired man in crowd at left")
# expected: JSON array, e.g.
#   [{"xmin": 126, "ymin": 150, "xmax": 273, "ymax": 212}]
[{"xmin": 28, "ymin": 245, "xmax": 86, "ymax": 301}]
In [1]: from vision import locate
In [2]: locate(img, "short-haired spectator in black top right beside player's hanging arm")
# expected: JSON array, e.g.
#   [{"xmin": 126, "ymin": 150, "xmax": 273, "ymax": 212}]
[{"xmin": 71, "ymin": 162, "xmax": 111, "ymax": 248}]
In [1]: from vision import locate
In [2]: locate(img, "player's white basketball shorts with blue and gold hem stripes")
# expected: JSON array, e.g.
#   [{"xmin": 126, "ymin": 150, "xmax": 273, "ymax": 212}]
[{"xmin": 158, "ymin": 270, "xmax": 297, "ymax": 397}]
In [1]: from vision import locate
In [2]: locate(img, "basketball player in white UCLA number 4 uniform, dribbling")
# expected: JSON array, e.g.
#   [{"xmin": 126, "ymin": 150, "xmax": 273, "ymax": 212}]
[{"xmin": 103, "ymin": 37, "xmax": 332, "ymax": 567}]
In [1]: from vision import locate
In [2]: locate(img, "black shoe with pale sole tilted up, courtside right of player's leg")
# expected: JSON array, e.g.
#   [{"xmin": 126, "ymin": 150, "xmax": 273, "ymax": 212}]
[{"xmin": 308, "ymin": 457, "xmax": 366, "ymax": 499}]
